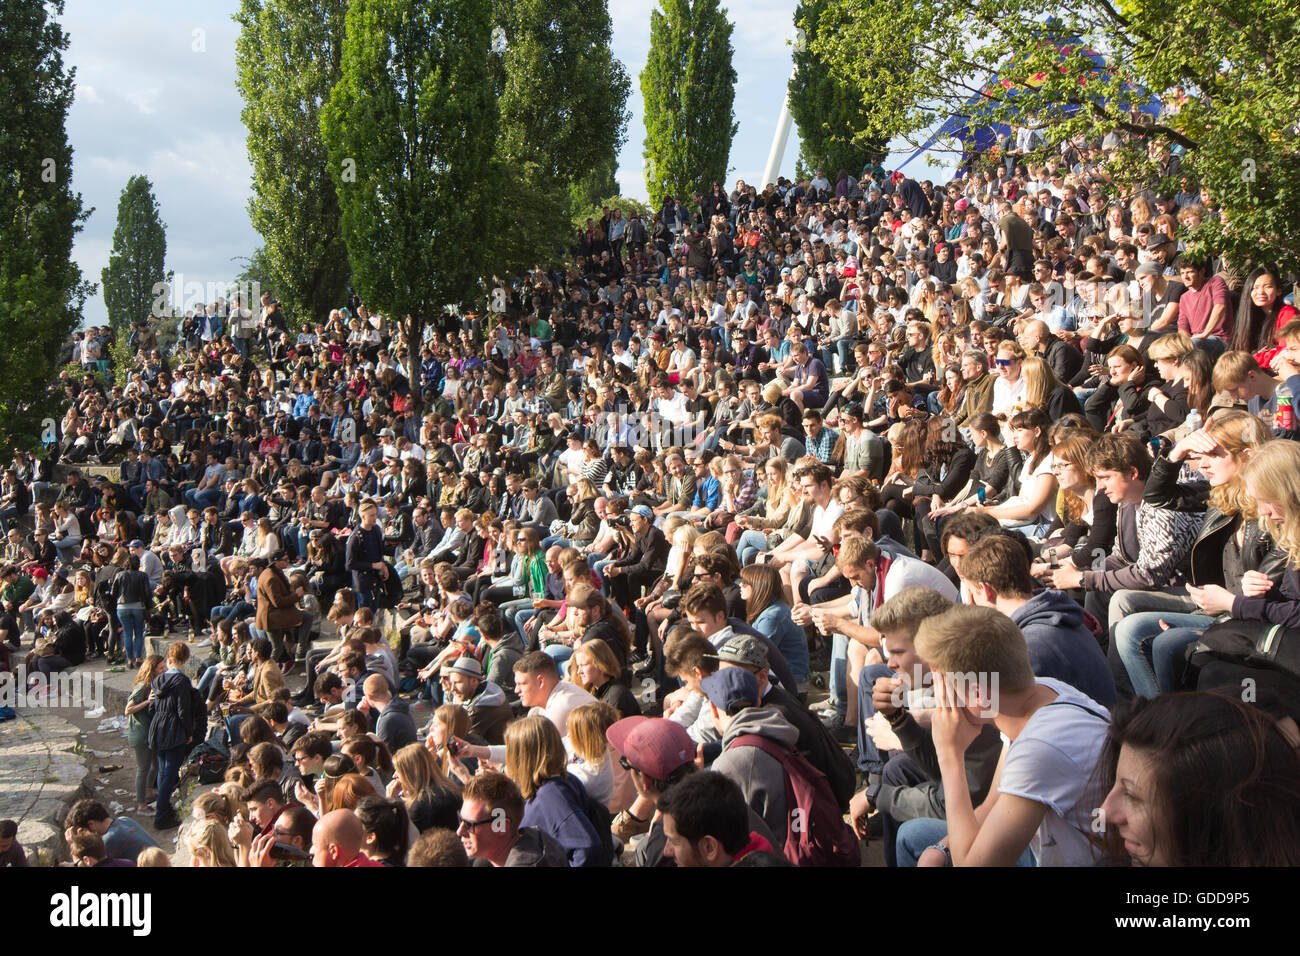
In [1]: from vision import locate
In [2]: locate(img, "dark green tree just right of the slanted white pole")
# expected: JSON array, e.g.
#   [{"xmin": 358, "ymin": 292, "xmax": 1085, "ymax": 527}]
[{"xmin": 790, "ymin": 0, "xmax": 883, "ymax": 177}]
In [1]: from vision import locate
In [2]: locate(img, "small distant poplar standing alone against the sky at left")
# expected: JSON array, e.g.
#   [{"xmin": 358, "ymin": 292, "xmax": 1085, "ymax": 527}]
[{"xmin": 100, "ymin": 176, "xmax": 172, "ymax": 334}]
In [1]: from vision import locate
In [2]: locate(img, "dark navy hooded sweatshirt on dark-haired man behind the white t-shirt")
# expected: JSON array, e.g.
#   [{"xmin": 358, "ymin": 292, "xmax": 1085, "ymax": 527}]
[{"xmin": 1011, "ymin": 589, "xmax": 1115, "ymax": 708}]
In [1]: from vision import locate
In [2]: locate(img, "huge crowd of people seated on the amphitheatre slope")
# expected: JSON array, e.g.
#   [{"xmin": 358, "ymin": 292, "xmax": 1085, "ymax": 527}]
[{"xmin": 0, "ymin": 130, "xmax": 1300, "ymax": 866}]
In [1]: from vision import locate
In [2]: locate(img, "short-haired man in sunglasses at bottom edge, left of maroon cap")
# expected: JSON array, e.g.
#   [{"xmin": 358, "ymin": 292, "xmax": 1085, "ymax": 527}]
[{"xmin": 456, "ymin": 773, "xmax": 568, "ymax": 866}]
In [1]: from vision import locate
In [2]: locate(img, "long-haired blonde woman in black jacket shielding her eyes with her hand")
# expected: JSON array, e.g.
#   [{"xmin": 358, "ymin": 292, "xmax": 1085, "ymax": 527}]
[{"xmin": 1112, "ymin": 411, "xmax": 1279, "ymax": 697}]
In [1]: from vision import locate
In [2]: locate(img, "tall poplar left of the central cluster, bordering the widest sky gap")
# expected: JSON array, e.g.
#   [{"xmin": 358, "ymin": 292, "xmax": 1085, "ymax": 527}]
[{"xmin": 234, "ymin": 0, "xmax": 348, "ymax": 324}]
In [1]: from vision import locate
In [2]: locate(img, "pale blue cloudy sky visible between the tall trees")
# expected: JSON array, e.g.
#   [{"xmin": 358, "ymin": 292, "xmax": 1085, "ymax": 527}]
[{"xmin": 62, "ymin": 0, "xmax": 946, "ymax": 324}]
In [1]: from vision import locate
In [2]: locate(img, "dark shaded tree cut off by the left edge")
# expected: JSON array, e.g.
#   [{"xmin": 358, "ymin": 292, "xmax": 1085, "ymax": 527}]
[{"xmin": 0, "ymin": 0, "xmax": 95, "ymax": 454}]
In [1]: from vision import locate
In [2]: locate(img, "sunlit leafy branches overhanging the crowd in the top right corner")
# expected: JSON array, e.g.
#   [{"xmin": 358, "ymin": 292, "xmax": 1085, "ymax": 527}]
[{"xmin": 813, "ymin": 0, "xmax": 1300, "ymax": 277}]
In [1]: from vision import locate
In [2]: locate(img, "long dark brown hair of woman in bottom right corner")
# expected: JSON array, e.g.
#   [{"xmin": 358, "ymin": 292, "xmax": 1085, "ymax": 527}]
[{"xmin": 1096, "ymin": 688, "xmax": 1300, "ymax": 866}]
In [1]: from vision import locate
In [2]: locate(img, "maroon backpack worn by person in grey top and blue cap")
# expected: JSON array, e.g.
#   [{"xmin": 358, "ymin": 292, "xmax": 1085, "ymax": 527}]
[{"xmin": 727, "ymin": 734, "xmax": 862, "ymax": 866}]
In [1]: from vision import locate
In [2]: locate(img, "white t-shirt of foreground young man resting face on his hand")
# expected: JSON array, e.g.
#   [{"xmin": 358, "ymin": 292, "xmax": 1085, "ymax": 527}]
[{"xmin": 997, "ymin": 678, "xmax": 1110, "ymax": 866}]
